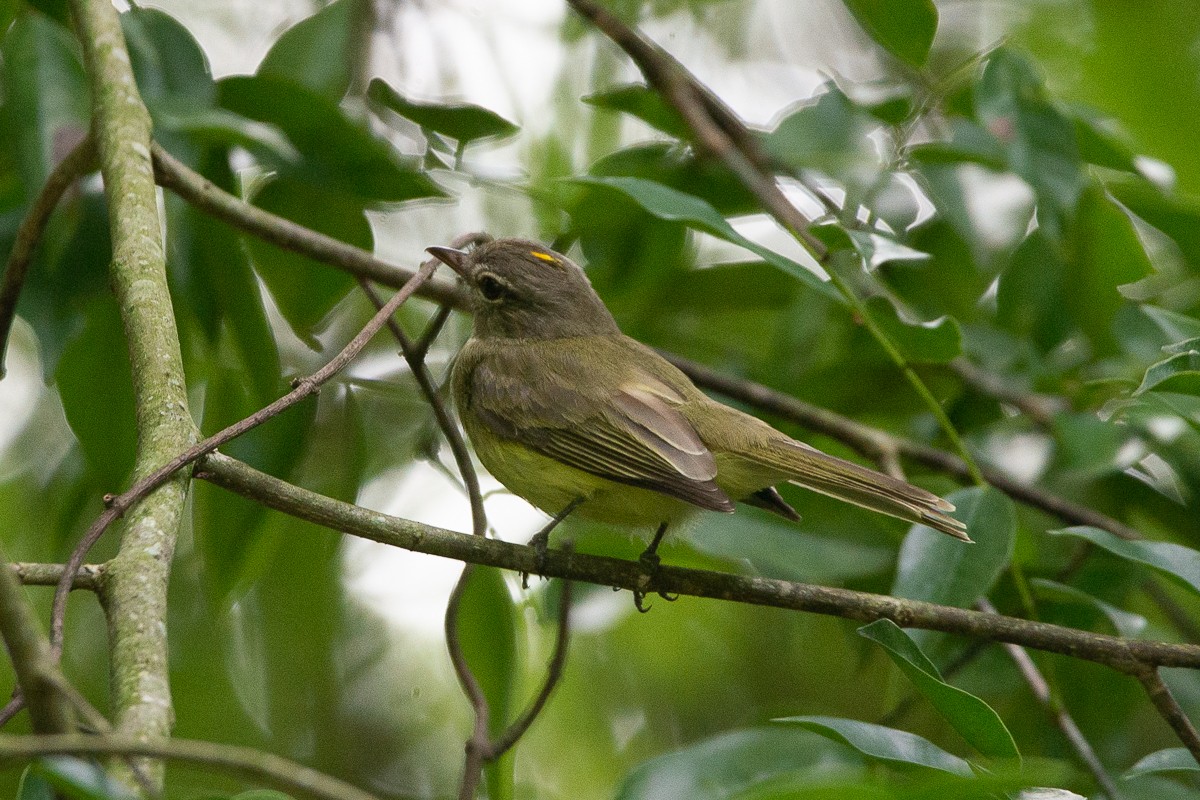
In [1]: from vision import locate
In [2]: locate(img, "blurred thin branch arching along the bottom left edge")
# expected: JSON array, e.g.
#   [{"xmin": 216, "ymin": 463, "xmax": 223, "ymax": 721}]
[{"xmin": 0, "ymin": 735, "xmax": 377, "ymax": 800}]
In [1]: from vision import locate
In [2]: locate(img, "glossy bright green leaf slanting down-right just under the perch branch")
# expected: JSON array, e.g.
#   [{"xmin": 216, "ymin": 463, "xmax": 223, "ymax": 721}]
[{"xmin": 858, "ymin": 619, "xmax": 1020, "ymax": 759}]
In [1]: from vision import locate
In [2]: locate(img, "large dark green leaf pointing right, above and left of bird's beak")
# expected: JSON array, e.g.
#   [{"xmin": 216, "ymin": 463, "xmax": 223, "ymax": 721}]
[{"xmin": 217, "ymin": 76, "xmax": 445, "ymax": 203}]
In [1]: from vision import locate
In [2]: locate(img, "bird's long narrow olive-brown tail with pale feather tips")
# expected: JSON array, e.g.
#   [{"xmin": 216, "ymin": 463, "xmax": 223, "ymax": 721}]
[{"xmin": 768, "ymin": 439, "xmax": 971, "ymax": 542}]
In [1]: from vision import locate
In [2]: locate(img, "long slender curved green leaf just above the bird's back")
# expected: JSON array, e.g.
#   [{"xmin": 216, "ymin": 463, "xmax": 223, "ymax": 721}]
[{"xmin": 570, "ymin": 176, "xmax": 841, "ymax": 300}]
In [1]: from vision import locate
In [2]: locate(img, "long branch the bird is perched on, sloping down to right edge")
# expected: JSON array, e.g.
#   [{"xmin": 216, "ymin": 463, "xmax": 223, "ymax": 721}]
[{"xmin": 197, "ymin": 453, "xmax": 1200, "ymax": 674}]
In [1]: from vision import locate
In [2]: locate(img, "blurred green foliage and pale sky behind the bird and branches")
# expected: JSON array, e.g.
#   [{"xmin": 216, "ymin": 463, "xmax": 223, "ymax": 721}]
[{"xmin": 0, "ymin": 0, "xmax": 1200, "ymax": 798}]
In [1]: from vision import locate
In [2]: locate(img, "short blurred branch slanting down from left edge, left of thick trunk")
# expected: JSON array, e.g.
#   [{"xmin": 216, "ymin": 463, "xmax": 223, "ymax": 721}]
[{"xmin": 0, "ymin": 553, "xmax": 74, "ymax": 733}]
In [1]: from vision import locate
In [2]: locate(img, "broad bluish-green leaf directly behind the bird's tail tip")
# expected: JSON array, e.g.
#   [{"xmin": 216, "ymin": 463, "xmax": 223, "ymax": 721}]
[{"xmin": 892, "ymin": 487, "xmax": 1016, "ymax": 608}]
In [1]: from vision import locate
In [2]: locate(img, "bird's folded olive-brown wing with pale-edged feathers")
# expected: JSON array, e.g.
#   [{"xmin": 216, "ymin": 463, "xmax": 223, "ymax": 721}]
[{"xmin": 468, "ymin": 345, "xmax": 733, "ymax": 511}]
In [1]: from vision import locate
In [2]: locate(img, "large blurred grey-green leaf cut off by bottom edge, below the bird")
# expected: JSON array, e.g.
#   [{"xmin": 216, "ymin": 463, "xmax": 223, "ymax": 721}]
[{"xmin": 616, "ymin": 728, "xmax": 860, "ymax": 800}]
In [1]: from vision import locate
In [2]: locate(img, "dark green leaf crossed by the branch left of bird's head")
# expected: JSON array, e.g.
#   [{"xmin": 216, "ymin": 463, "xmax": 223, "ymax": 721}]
[{"xmin": 246, "ymin": 179, "xmax": 360, "ymax": 349}]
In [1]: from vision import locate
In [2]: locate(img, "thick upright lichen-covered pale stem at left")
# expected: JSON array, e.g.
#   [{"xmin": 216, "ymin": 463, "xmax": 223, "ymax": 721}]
[{"xmin": 69, "ymin": 0, "xmax": 197, "ymax": 767}]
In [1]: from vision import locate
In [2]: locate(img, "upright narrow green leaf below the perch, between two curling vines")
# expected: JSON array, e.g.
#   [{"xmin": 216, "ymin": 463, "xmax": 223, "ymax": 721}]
[{"xmin": 458, "ymin": 565, "xmax": 520, "ymax": 799}]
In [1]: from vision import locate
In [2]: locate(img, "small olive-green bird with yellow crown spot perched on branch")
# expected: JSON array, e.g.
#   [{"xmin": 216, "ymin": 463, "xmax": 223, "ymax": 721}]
[{"xmin": 428, "ymin": 239, "xmax": 971, "ymax": 560}]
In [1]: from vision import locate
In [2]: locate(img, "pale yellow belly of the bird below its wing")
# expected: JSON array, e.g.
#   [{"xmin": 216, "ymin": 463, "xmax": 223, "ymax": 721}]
[{"xmin": 463, "ymin": 420, "xmax": 696, "ymax": 528}]
